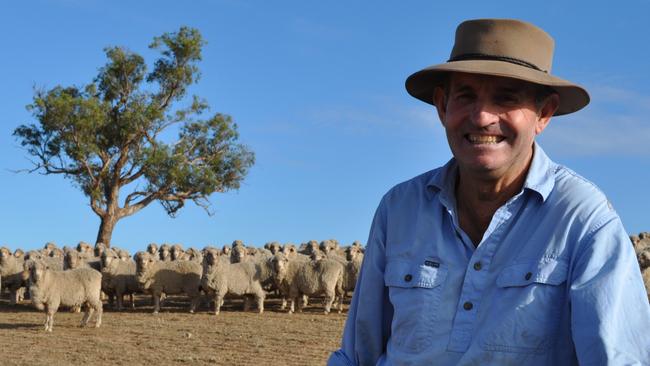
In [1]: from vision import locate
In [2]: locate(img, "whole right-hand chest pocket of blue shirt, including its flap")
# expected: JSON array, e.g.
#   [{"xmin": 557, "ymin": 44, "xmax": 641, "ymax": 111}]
[{"xmin": 483, "ymin": 259, "xmax": 568, "ymax": 354}]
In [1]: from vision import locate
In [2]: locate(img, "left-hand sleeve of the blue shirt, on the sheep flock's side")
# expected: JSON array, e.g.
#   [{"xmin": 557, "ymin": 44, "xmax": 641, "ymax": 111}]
[{"xmin": 327, "ymin": 199, "xmax": 393, "ymax": 366}]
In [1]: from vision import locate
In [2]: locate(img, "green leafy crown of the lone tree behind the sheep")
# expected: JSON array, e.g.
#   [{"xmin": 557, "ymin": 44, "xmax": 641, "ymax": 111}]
[{"xmin": 14, "ymin": 27, "xmax": 255, "ymax": 229}]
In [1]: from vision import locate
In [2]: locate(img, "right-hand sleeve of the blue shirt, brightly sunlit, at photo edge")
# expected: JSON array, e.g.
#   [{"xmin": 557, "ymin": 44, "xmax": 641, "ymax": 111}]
[{"xmin": 569, "ymin": 215, "xmax": 650, "ymax": 365}]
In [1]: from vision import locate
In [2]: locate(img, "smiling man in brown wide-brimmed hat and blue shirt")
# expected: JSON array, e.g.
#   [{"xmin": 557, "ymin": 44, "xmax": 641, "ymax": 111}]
[{"xmin": 329, "ymin": 19, "xmax": 650, "ymax": 365}]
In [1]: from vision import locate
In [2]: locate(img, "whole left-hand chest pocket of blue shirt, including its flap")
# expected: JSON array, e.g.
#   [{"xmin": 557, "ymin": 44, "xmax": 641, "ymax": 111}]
[{"xmin": 384, "ymin": 260, "xmax": 447, "ymax": 352}]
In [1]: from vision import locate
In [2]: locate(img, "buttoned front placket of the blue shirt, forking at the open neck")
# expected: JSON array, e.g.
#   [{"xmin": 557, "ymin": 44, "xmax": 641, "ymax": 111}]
[{"xmin": 447, "ymin": 193, "xmax": 522, "ymax": 352}]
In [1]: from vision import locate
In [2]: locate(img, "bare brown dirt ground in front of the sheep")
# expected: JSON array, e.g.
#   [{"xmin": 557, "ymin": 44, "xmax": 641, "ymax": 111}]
[{"xmin": 0, "ymin": 294, "xmax": 347, "ymax": 366}]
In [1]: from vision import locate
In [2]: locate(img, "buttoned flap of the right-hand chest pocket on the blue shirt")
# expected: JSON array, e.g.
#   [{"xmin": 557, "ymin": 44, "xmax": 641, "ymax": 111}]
[{"xmin": 497, "ymin": 259, "xmax": 569, "ymax": 287}]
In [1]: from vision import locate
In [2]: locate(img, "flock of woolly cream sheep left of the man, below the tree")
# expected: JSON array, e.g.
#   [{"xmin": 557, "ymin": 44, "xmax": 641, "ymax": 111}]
[{"xmin": 0, "ymin": 240, "xmax": 364, "ymax": 332}]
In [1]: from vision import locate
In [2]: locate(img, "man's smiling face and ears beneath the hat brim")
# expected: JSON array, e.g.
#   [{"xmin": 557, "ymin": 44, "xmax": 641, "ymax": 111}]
[{"xmin": 434, "ymin": 73, "xmax": 558, "ymax": 179}]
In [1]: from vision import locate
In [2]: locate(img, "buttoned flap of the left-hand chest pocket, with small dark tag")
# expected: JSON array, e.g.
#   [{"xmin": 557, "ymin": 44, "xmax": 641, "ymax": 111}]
[{"xmin": 384, "ymin": 259, "xmax": 447, "ymax": 288}]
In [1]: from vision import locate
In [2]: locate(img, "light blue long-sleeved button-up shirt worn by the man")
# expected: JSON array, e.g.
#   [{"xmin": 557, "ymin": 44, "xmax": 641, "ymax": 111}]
[{"xmin": 328, "ymin": 145, "xmax": 650, "ymax": 366}]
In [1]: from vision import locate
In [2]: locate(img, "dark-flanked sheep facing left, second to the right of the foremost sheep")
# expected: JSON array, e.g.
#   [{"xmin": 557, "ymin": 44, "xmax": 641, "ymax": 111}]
[{"xmin": 135, "ymin": 252, "xmax": 203, "ymax": 314}]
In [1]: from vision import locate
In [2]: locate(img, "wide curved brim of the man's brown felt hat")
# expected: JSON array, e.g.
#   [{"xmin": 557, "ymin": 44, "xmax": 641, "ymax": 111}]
[{"xmin": 406, "ymin": 60, "xmax": 589, "ymax": 116}]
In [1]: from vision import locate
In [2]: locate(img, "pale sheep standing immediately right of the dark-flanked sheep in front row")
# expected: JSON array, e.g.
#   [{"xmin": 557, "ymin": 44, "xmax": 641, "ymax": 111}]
[{"xmin": 201, "ymin": 251, "xmax": 266, "ymax": 315}]
